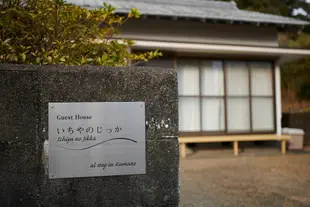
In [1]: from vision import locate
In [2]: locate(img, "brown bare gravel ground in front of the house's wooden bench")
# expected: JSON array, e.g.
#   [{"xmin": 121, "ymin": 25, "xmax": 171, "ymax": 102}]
[{"xmin": 180, "ymin": 152, "xmax": 310, "ymax": 207}]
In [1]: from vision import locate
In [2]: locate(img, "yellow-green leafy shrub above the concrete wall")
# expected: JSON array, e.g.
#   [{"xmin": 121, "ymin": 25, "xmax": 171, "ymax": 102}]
[{"xmin": 0, "ymin": 0, "xmax": 162, "ymax": 66}]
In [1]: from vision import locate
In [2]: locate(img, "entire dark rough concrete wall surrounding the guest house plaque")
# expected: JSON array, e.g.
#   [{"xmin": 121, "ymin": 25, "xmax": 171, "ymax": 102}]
[{"xmin": 0, "ymin": 65, "xmax": 179, "ymax": 207}]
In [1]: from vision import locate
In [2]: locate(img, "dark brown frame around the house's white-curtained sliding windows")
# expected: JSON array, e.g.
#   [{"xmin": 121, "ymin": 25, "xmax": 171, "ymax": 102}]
[{"xmin": 134, "ymin": 49, "xmax": 278, "ymax": 136}]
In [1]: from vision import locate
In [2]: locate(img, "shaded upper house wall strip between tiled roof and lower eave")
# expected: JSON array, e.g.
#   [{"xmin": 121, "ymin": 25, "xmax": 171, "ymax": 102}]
[{"xmin": 122, "ymin": 19, "xmax": 278, "ymax": 47}]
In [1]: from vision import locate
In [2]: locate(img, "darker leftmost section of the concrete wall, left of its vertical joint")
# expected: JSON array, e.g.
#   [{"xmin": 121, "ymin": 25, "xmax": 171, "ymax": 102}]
[{"xmin": 0, "ymin": 65, "xmax": 42, "ymax": 207}]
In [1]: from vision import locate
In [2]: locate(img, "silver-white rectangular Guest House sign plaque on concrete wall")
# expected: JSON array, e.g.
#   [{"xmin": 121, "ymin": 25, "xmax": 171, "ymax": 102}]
[{"xmin": 48, "ymin": 102, "xmax": 146, "ymax": 179}]
